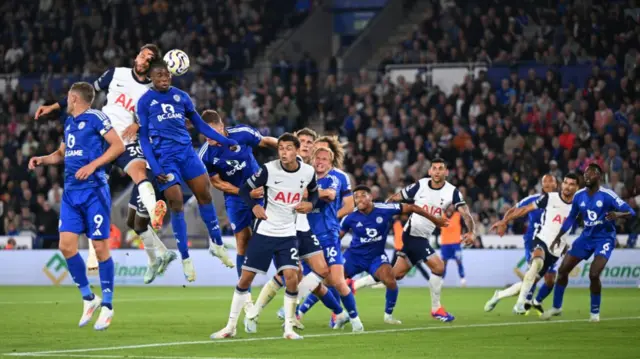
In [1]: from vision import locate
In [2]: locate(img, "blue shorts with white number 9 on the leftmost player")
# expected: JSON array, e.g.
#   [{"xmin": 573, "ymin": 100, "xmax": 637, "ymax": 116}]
[{"xmin": 58, "ymin": 185, "xmax": 111, "ymax": 239}]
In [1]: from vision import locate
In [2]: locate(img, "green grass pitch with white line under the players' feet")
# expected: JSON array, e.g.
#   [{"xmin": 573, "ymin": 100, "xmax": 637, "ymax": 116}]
[{"xmin": 0, "ymin": 287, "xmax": 640, "ymax": 359}]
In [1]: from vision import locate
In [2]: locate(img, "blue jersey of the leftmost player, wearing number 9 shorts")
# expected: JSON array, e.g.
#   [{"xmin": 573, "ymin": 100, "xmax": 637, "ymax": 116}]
[{"xmin": 63, "ymin": 109, "xmax": 111, "ymax": 190}]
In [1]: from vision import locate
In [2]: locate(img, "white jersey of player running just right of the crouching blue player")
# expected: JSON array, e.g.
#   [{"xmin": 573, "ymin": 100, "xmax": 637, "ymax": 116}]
[{"xmin": 400, "ymin": 178, "xmax": 465, "ymax": 239}]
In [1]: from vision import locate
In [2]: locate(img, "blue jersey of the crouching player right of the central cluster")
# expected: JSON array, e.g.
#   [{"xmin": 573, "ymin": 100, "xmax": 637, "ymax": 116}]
[{"xmin": 340, "ymin": 203, "xmax": 402, "ymax": 257}]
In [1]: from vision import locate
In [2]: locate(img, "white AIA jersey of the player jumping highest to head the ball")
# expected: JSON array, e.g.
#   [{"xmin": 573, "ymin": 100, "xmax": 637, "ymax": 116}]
[{"xmin": 93, "ymin": 67, "xmax": 151, "ymax": 145}]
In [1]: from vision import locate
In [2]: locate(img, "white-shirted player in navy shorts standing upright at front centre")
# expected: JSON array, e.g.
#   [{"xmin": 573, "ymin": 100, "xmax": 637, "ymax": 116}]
[{"xmin": 211, "ymin": 133, "xmax": 318, "ymax": 339}]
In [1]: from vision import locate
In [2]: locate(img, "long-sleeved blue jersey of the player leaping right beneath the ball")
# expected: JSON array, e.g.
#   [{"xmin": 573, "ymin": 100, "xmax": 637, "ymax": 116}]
[{"xmin": 136, "ymin": 87, "xmax": 237, "ymax": 176}]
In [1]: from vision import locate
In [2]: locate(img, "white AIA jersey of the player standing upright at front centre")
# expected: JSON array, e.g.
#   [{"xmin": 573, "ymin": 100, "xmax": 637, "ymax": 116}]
[{"xmin": 247, "ymin": 160, "xmax": 318, "ymax": 237}]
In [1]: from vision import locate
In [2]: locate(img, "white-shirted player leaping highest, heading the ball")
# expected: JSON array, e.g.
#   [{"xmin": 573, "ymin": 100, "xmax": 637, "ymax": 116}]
[{"xmin": 35, "ymin": 44, "xmax": 176, "ymax": 284}]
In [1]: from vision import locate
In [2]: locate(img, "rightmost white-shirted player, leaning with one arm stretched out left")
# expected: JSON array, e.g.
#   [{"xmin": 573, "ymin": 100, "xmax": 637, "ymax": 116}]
[{"xmin": 492, "ymin": 173, "xmax": 579, "ymax": 314}]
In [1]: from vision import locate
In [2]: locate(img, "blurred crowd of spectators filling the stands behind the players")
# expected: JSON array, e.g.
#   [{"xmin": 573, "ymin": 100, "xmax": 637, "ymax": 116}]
[{"xmin": 0, "ymin": 0, "xmax": 640, "ymax": 246}]
